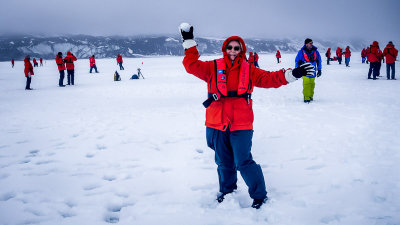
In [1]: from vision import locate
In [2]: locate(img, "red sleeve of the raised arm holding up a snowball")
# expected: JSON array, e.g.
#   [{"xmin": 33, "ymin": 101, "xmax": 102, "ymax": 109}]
[{"xmin": 182, "ymin": 47, "xmax": 214, "ymax": 82}]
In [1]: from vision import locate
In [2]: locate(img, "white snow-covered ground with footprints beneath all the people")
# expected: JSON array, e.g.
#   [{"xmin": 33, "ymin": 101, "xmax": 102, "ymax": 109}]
[{"xmin": 0, "ymin": 53, "xmax": 400, "ymax": 225}]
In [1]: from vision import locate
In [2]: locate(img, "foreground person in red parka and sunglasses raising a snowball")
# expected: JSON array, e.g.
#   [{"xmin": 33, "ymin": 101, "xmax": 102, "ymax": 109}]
[{"xmin": 179, "ymin": 23, "xmax": 315, "ymax": 209}]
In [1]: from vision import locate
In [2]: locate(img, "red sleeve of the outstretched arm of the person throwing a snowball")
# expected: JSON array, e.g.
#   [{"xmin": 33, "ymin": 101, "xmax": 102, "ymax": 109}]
[{"xmin": 251, "ymin": 67, "xmax": 288, "ymax": 88}]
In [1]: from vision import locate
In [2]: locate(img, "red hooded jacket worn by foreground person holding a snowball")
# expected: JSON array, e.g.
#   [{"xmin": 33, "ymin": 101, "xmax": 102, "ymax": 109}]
[{"xmin": 183, "ymin": 36, "xmax": 288, "ymax": 131}]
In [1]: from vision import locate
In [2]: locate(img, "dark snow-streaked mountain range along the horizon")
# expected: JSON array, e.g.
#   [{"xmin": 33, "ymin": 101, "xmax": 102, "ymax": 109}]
[{"xmin": 0, "ymin": 35, "xmax": 369, "ymax": 61}]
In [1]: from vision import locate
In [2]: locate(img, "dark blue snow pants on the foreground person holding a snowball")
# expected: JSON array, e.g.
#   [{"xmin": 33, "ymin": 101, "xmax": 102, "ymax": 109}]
[{"xmin": 206, "ymin": 127, "xmax": 267, "ymax": 199}]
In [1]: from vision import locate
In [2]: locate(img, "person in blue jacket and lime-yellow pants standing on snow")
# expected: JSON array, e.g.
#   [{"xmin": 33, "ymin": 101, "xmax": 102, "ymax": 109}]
[{"xmin": 295, "ymin": 38, "xmax": 322, "ymax": 103}]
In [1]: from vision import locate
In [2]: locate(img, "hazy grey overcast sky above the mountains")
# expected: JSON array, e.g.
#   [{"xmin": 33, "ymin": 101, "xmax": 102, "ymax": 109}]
[{"xmin": 0, "ymin": 0, "xmax": 400, "ymax": 40}]
